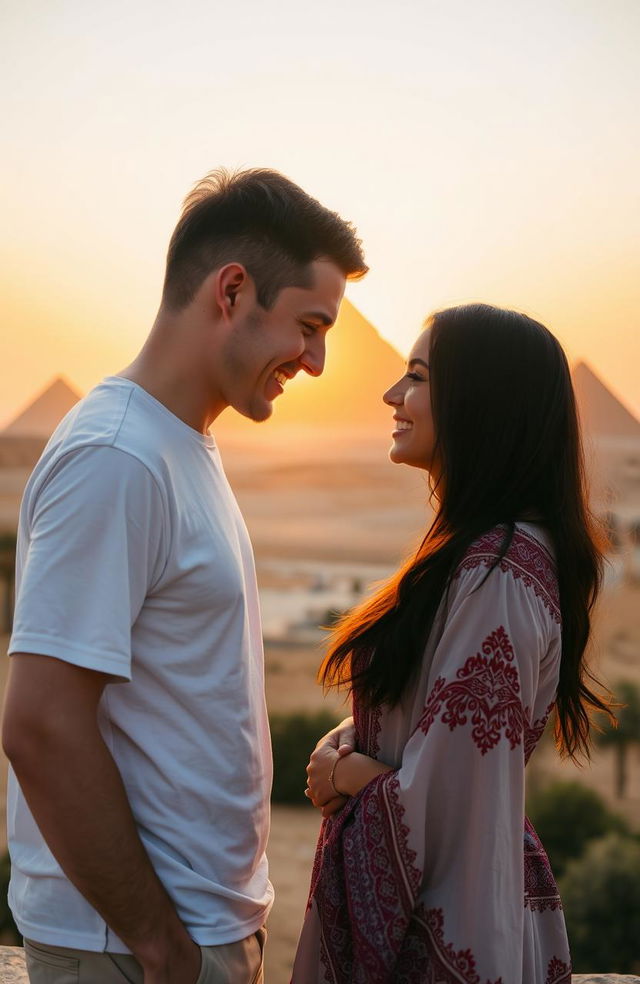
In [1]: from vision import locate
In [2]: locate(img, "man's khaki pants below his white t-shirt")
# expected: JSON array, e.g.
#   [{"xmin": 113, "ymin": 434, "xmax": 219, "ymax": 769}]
[{"xmin": 24, "ymin": 929, "xmax": 267, "ymax": 984}]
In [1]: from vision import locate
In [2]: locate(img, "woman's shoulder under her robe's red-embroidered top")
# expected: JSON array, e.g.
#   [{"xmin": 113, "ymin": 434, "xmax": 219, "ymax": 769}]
[{"xmin": 453, "ymin": 522, "xmax": 560, "ymax": 622}]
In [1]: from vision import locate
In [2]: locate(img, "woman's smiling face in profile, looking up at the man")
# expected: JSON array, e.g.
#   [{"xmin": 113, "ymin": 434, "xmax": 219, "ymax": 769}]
[{"xmin": 383, "ymin": 328, "xmax": 436, "ymax": 474}]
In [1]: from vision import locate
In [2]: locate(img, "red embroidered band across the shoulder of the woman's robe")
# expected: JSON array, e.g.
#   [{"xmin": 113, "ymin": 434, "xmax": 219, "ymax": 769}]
[{"xmin": 455, "ymin": 526, "xmax": 560, "ymax": 623}]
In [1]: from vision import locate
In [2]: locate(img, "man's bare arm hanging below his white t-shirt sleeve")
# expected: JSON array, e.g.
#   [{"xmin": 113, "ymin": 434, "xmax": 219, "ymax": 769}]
[{"xmin": 2, "ymin": 653, "xmax": 200, "ymax": 984}]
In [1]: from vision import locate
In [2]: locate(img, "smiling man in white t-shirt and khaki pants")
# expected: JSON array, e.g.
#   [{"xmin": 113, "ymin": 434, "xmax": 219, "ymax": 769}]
[{"xmin": 3, "ymin": 170, "xmax": 367, "ymax": 984}]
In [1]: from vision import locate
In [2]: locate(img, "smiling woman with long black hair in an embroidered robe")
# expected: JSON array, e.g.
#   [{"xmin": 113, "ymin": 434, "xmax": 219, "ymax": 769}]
[{"xmin": 293, "ymin": 304, "xmax": 607, "ymax": 984}]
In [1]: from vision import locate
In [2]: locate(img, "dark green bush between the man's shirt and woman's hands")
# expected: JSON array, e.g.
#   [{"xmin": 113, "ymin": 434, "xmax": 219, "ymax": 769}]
[{"xmin": 271, "ymin": 711, "xmax": 338, "ymax": 804}]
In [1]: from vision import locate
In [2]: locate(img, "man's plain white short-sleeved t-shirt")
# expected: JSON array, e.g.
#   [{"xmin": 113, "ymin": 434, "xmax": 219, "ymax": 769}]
[{"xmin": 8, "ymin": 377, "xmax": 273, "ymax": 952}]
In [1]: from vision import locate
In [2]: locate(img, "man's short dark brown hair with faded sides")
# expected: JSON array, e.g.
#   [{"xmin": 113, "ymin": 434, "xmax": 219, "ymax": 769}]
[{"xmin": 162, "ymin": 168, "xmax": 368, "ymax": 310}]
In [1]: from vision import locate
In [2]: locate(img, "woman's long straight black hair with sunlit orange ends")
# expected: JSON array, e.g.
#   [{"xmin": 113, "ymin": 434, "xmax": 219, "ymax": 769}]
[{"xmin": 320, "ymin": 304, "xmax": 608, "ymax": 757}]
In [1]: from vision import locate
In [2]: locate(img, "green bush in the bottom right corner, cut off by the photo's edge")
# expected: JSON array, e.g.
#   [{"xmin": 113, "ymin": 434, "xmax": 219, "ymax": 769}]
[{"xmin": 560, "ymin": 834, "xmax": 640, "ymax": 974}]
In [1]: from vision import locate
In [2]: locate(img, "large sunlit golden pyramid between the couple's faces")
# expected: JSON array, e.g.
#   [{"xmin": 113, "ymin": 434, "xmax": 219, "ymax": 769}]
[{"xmin": 213, "ymin": 298, "xmax": 404, "ymax": 439}]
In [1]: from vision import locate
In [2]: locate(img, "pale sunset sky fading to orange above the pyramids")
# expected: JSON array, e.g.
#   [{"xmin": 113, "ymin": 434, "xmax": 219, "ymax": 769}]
[{"xmin": 0, "ymin": 0, "xmax": 640, "ymax": 424}]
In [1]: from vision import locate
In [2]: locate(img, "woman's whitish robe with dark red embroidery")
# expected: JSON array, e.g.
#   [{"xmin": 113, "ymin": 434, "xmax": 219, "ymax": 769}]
[{"xmin": 292, "ymin": 524, "xmax": 570, "ymax": 984}]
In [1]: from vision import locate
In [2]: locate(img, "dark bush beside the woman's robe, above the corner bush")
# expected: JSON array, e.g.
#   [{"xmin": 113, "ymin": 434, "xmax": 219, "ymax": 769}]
[{"xmin": 527, "ymin": 782, "xmax": 627, "ymax": 878}]
